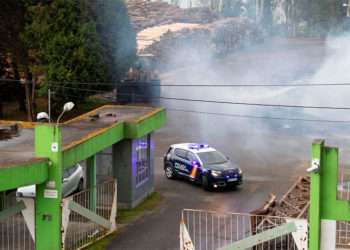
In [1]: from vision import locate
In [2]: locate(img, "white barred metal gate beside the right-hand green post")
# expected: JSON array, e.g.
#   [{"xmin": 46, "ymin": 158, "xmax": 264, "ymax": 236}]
[{"xmin": 182, "ymin": 209, "xmax": 307, "ymax": 250}]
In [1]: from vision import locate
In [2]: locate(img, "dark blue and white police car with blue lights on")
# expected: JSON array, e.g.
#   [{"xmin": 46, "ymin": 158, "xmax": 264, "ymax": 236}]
[{"xmin": 164, "ymin": 143, "xmax": 243, "ymax": 190}]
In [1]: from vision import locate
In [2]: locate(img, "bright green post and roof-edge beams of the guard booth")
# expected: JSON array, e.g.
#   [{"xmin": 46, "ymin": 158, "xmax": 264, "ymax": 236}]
[{"xmin": 0, "ymin": 107, "xmax": 166, "ymax": 250}]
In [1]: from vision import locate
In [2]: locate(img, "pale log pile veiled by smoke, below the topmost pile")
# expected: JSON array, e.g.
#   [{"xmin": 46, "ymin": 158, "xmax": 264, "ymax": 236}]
[{"xmin": 137, "ymin": 18, "xmax": 262, "ymax": 69}]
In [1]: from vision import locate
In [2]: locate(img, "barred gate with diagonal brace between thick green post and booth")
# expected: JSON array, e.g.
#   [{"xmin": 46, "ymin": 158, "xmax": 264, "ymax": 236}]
[{"xmin": 62, "ymin": 180, "xmax": 117, "ymax": 250}]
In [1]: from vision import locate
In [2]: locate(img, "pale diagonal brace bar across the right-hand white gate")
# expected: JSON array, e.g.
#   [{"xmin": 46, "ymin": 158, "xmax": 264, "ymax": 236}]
[{"xmin": 218, "ymin": 222, "xmax": 297, "ymax": 250}]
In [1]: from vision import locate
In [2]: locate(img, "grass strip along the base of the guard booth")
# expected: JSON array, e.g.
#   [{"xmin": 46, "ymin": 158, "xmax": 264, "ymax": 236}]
[{"xmin": 84, "ymin": 192, "xmax": 162, "ymax": 250}]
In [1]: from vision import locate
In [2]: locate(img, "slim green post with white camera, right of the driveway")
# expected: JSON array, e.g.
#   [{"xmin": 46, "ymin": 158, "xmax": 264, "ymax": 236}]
[{"xmin": 309, "ymin": 140, "xmax": 324, "ymax": 250}]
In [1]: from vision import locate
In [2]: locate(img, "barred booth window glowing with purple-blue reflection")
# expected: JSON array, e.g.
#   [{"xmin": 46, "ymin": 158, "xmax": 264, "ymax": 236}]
[{"xmin": 135, "ymin": 136, "xmax": 150, "ymax": 186}]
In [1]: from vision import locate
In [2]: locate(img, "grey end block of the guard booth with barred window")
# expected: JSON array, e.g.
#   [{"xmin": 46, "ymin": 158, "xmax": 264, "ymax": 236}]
[{"xmin": 112, "ymin": 135, "xmax": 154, "ymax": 208}]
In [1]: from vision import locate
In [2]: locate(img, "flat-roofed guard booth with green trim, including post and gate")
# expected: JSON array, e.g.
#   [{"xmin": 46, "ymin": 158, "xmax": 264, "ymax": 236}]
[{"xmin": 0, "ymin": 106, "xmax": 166, "ymax": 250}]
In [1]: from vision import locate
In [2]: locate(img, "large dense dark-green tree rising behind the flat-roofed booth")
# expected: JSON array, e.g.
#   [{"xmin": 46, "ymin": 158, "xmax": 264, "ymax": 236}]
[{"xmin": 23, "ymin": 0, "xmax": 136, "ymax": 115}]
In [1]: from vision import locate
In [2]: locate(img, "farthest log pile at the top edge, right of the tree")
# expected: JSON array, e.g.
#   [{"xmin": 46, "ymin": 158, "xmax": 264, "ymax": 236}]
[{"xmin": 127, "ymin": 0, "xmax": 218, "ymax": 33}]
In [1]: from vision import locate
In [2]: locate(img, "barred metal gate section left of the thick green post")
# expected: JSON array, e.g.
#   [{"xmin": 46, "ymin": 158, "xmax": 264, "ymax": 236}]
[{"xmin": 0, "ymin": 194, "xmax": 35, "ymax": 250}]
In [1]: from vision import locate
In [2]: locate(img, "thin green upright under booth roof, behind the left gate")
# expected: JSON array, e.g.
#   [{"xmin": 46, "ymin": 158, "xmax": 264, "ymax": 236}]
[{"xmin": 86, "ymin": 155, "xmax": 96, "ymax": 212}]
